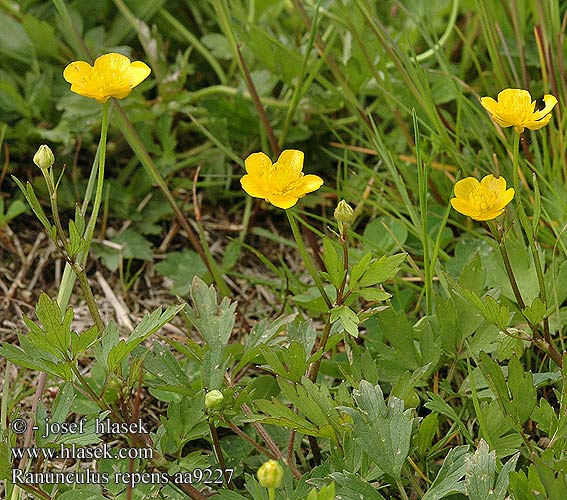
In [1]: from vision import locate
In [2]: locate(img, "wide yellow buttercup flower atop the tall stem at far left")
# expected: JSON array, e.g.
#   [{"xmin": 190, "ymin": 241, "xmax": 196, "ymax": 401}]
[{"xmin": 63, "ymin": 53, "xmax": 151, "ymax": 103}]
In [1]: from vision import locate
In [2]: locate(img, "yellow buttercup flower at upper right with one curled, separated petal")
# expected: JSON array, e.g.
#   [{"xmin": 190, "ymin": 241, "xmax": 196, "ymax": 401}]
[{"xmin": 480, "ymin": 89, "xmax": 557, "ymax": 134}]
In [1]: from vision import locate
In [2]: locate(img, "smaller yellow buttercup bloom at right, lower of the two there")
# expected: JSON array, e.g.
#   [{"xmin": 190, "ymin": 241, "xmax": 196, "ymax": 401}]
[{"xmin": 451, "ymin": 174, "xmax": 514, "ymax": 220}]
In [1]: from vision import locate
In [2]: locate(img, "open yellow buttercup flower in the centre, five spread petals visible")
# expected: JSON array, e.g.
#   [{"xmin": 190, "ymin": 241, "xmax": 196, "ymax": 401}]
[{"xmin": 240, "ymin": 149, "xmax": 323, "ymax": 209}]
